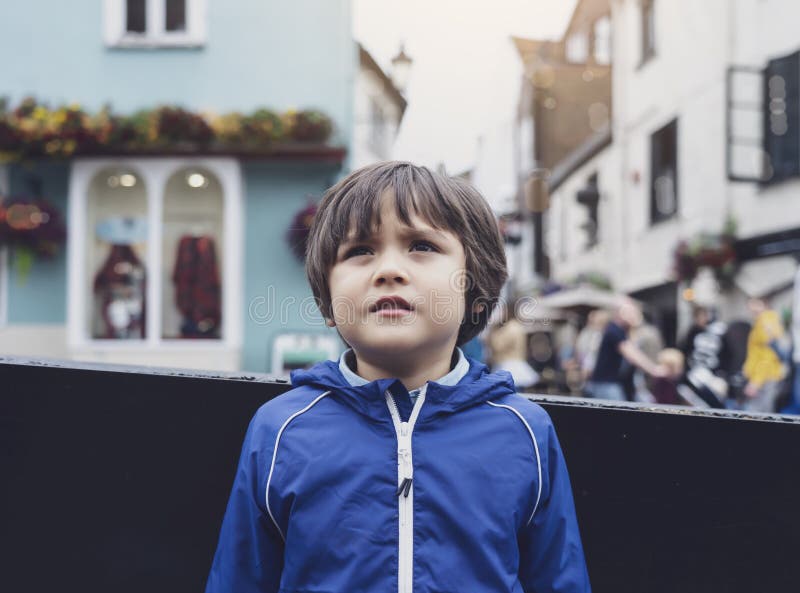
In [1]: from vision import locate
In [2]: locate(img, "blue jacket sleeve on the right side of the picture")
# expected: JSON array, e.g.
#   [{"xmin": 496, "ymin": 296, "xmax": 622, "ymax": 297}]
[{"xmin": 518, "ymin": 411, "xmax": 591, "ymax": 593}]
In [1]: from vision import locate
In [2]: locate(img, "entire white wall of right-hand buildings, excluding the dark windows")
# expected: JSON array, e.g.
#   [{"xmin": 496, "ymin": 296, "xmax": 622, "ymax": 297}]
[{"xmin": 549, "ymin": 0, "xmax": 800, "ymax": 306}]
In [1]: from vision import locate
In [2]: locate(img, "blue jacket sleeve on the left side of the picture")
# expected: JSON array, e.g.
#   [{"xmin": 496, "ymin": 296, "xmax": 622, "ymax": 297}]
[{"xmin": 206, "ymin": 413, "xmax": 284, "ymax": 593}]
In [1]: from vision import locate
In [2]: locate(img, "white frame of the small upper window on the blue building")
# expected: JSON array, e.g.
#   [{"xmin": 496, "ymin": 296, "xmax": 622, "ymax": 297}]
[{"xmin": 103, "ymin": 0, "xmax": 208, "ymax": 48}]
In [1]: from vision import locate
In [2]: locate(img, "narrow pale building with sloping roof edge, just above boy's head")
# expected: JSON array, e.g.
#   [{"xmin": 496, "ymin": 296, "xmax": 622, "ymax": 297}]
[{"xmin": 351, "ymin": 43, "xmax": 407, "ymax": 169}]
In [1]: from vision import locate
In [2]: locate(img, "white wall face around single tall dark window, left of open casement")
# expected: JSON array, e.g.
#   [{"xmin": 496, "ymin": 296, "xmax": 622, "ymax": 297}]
[{"xmin": 613, "ymin": 0, "xmax": 727, "ymax": 292}]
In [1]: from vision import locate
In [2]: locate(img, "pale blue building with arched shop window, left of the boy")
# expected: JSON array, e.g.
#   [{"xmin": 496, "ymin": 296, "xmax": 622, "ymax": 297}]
[{"xmin": 0, "ymin": 0, "xmax": 358, "ymax": 371}]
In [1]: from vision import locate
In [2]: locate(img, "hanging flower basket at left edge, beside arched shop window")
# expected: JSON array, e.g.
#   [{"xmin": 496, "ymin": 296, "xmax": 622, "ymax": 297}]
[{"xmin": 0, "ymin": 197, "xmax": 67, "ymax": 282}]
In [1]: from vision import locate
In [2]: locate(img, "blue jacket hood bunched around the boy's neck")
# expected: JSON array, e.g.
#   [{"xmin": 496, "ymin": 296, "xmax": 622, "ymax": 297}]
[{"xmin": 291, "ymin": 358, "xmax": 516, "ymax": 421}]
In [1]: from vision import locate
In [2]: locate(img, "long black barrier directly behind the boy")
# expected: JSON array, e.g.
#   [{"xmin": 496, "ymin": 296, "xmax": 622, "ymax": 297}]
[{"xmin": 0, "ymin": 359, "xmax": 800, "ymax": 593}]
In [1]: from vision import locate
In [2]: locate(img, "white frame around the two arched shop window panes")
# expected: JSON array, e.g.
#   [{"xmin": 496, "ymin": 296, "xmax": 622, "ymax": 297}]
[{"xmin": 67, "ymin": 157, "xmax": 244, "ymax": 352}]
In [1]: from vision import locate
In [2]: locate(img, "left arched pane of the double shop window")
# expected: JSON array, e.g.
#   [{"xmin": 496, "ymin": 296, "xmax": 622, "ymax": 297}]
[{"xmin": 84, "ymin": 168, "xmax": 147, "ymax": 340}]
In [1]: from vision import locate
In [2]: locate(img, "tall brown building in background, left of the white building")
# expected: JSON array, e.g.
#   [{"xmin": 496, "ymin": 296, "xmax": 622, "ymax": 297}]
[{"xmin": 514, "ymin": 0, "xmax": 612, "ymax": 288}]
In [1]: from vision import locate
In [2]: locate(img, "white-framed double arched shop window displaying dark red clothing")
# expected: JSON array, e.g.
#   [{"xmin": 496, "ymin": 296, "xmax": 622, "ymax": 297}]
[{"xmin": 67, "ymin": 158, "xmax": 243, "ymax": 350}]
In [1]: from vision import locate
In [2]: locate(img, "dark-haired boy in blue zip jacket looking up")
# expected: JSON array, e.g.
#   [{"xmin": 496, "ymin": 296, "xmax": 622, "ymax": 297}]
[{"xmin": 206, "ymin": 163, "xmax": 589, "ymax": 593}]
